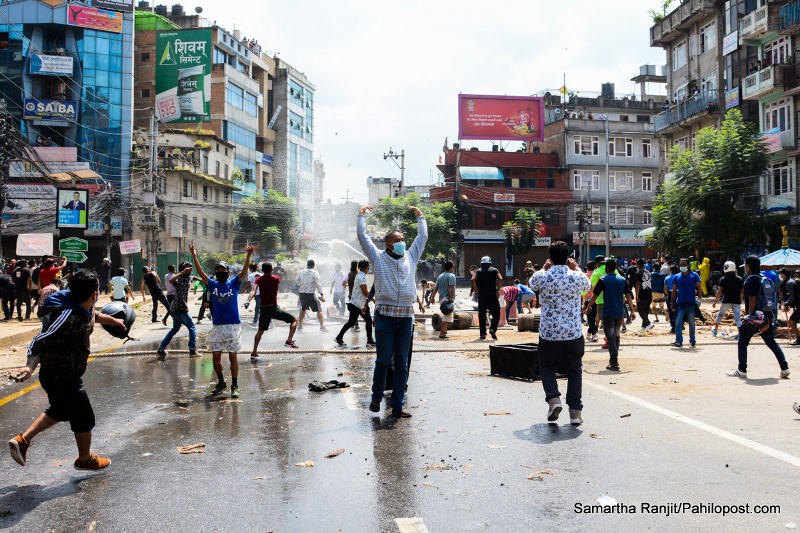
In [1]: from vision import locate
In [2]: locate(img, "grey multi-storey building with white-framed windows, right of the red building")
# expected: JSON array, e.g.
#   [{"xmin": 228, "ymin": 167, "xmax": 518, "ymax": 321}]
[{"xmin": 533, "ymin": 78, "xmax": 665, "ymax": 262}]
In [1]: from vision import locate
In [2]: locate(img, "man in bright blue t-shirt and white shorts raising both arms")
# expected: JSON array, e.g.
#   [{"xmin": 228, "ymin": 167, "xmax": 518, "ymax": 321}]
[{"xmin": 189, "ymin": 244, "xmax": 255, "ymax": 398}]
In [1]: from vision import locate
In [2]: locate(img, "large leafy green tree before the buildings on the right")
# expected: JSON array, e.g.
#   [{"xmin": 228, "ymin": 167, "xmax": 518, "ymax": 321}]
[{"xmin": 651, "ymin": 109, "xmax": 778, "ymax": 255}]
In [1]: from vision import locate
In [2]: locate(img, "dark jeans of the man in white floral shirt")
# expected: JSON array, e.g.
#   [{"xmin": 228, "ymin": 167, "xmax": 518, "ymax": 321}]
[{"xmin": 537, "ymin": 336, "xmax": 588, "ymax": 411}]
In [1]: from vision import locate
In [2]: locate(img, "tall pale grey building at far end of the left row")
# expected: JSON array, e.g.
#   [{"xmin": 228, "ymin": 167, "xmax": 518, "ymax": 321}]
[{"xmin": 270, "ymin": 59, "xmax": 315, "ymax": 235}]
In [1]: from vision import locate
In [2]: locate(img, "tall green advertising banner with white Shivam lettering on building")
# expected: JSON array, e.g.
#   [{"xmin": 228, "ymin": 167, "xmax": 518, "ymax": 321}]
[{"xmin": 156, "ymin": 28, "xmax": 213, "ymax": 122}]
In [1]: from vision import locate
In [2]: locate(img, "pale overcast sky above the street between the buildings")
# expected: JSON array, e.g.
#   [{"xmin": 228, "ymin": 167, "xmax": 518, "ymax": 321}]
[{"xmin": 212, "ymin": 0, "xmax": 666, "ymax": 203}]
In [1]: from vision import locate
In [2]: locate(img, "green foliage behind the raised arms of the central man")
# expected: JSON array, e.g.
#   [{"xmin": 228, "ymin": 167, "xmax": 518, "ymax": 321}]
[{"xmin": 372, "ymin": 193, "xmax": 457, "ymax": 259}]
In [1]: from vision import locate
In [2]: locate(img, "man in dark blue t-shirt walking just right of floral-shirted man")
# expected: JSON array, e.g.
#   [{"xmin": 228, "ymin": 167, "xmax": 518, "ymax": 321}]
[{"xmin": 585, "ymin": 259, "xmax": 636, "ymax": 372}]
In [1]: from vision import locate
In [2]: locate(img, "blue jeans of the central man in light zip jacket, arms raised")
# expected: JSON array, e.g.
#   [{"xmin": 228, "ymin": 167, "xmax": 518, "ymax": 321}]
[{"xmin": 372, "ymin": 313, "xmax": 414, "ymax": 409}]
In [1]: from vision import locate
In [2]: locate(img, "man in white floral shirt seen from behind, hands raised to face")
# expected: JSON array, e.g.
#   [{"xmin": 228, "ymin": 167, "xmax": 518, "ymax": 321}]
[{"xmin": 530, "ymin": 241, "xmax": 591, "ymax": 425}]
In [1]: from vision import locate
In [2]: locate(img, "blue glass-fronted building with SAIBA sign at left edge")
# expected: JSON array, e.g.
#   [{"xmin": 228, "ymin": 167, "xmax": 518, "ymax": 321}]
[{"xmin": 0, "ymin": 0, "xmax": 134, "ymax": 264}]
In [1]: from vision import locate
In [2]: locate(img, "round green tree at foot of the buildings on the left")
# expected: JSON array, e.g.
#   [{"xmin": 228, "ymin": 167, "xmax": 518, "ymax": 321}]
[{"xmin": 236, "ymin": 190, "xmax": 297, "ymax": 254}]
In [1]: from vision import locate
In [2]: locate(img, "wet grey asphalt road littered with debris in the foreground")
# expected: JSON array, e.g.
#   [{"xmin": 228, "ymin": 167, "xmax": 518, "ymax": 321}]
[{"xmin": 0, "ymin": 312, "xmax": 800, "ymax": 532}]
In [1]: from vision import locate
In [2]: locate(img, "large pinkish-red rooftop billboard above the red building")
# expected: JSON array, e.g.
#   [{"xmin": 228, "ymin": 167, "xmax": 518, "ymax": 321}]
[{"xmin": 458, "ymin": 94, "xmax": 544, "ymax": 141}]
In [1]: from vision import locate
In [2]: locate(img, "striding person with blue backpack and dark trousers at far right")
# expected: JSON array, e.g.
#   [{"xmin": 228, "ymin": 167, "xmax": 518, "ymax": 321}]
[{"xmin": 727, "ymin": 255, "xmax": 789, "ymax": 379}]
